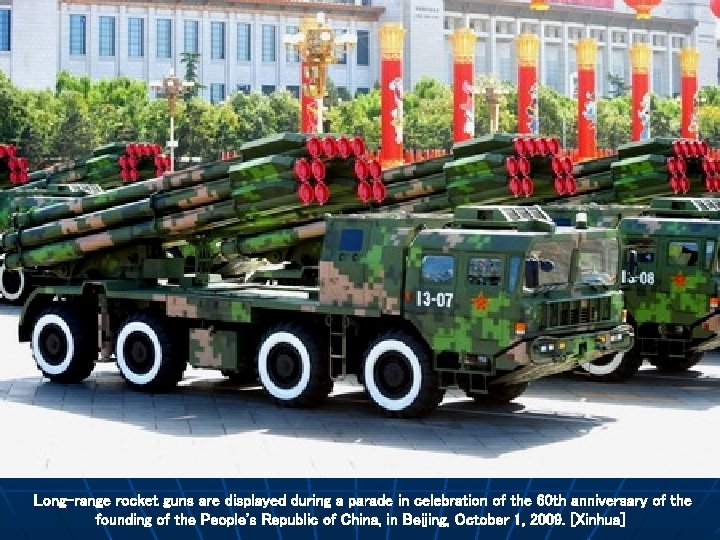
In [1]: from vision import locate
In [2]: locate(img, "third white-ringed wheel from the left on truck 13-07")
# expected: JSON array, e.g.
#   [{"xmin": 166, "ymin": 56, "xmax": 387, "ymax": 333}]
[{"xmin": 256, "ymin": 324, "xmax": 333, "ymax": 407}]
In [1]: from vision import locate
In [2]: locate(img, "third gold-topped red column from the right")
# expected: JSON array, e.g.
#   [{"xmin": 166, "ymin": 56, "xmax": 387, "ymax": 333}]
[{"xmin": 575, "ymin": 38, "xmax": 597, "ymax": 159}]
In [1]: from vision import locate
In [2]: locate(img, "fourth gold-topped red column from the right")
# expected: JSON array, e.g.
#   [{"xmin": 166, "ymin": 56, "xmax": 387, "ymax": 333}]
[{"xmin": 515, "ymin": 33, "xmax": 540, "ymax": 135}]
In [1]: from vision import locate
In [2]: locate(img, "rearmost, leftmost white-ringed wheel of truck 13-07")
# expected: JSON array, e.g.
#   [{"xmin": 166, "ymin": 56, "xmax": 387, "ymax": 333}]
[{"xmin": 30, "ymin": 306, "xmax": 98, "ymax": 383}]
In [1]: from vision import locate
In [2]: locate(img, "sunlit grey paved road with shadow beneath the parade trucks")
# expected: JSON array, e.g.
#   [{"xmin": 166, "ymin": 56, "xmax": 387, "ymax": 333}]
[{"xmin": 0, "ymin": 306, "xmax": 720, "ymax": 478}]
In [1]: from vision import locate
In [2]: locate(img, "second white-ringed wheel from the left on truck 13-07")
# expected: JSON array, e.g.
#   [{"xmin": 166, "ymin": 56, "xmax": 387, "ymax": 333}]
[{"xmin": 115, "ymin": 314, "xmax": 187, "ymax": 392}]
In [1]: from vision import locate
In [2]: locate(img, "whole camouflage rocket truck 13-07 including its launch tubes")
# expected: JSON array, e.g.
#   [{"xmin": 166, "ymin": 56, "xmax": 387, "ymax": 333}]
[{"xmin": 1, "ymin": 134, "xmax": 632, "ymax": 417}]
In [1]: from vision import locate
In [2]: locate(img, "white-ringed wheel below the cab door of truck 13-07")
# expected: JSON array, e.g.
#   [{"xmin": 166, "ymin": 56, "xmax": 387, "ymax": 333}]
[{"xmin": 363, "ymin": 331, "xmax": 443, "ymax": 418}]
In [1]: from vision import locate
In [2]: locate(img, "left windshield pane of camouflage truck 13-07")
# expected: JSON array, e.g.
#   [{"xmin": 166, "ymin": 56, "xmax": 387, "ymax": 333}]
[{"xmin": 524, "ymin": 240, "xmax": 573, "ymax": 291}]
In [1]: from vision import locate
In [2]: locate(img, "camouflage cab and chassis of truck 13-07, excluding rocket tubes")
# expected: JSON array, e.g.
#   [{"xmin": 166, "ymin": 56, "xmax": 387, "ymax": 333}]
[{"xmin": 11, "ymin": 206, "xmax": 632, "ymax": 417}]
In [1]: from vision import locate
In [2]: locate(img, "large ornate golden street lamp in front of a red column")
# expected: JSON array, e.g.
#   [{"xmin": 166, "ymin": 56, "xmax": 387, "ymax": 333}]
[{"xmin": 283, "ymin": 13, "xmax": 357, "ymax": 133}]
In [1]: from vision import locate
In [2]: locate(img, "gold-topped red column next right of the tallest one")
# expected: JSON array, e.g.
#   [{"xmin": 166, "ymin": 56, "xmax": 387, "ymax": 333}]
[{"xmin": 450, "ymin": 28, "xmax": 477, "ymax": 142}]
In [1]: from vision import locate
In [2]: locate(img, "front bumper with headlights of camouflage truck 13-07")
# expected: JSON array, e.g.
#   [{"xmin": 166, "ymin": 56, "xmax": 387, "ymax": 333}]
[{"xmin": 495, "ymin": 324, "xmax": 635, "ymax": 384}]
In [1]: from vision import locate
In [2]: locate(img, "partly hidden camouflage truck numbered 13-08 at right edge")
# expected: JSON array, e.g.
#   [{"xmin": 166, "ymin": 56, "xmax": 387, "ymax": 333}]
[{"xmin": 545, "ymin": 197, "xmax": 720, "ymax": 381}]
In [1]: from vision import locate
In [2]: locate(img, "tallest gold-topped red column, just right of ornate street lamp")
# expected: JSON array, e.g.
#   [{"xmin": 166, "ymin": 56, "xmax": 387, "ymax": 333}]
[{"xmin": 380, "ymin": 23, "xmax": 405, "ymax": 169}]
